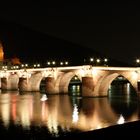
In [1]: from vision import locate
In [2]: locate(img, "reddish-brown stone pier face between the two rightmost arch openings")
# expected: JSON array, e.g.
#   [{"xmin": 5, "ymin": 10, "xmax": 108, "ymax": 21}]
[{"xmin": 82, "ymin": 77, "xmax": 94, "ymax": 97}]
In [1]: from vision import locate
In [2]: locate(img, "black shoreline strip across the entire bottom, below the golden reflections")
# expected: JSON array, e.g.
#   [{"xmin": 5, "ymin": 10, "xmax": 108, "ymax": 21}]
[{"xmin": 0, "ymin": 121, "xmax": 140, "ymax": 140}]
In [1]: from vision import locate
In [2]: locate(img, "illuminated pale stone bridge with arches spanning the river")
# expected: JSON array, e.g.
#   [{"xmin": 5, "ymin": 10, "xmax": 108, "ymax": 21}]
[{"xmin": 0, "ymin": 65, "xmax": 140, "ymax": 97}]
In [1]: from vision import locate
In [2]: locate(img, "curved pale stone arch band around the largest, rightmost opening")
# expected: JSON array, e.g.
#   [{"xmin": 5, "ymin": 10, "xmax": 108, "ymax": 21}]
[{"xmin": 95, "ymin": 72, "xmax": 137, "ymax": 96}]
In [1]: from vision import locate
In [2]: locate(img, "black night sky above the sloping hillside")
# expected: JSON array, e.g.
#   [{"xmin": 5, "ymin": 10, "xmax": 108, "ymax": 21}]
[{"xmin": 0, "ymin": 1, "xmax": 140, "ymax": 62}]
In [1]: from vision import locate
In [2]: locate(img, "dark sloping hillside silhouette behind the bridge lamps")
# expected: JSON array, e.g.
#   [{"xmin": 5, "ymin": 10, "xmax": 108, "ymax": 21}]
[{"xmin": 0, "ymin": 20, "xmax": 130, "ymax": 66}]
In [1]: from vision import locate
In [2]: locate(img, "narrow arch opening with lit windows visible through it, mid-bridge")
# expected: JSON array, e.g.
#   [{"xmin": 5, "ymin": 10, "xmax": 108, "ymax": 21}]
[{"xmin": 68, "ymin": 75, "xmax": 82, "ymax": 96}]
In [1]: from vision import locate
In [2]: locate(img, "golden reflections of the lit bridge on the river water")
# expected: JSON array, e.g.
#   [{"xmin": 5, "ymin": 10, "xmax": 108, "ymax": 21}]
[{"xmin": 0, "ymin": 83, "xmax": 140, "ymax": 136}]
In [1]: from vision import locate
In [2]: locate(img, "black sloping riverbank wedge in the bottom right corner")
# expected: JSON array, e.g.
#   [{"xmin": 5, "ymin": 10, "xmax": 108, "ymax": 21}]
[{"xmin": 60, "ymin": 121, "xmax": 140, "ymax": 140}]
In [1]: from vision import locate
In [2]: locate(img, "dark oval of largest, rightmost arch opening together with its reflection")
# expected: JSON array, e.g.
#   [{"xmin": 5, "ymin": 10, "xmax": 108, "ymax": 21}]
[{"xmin": 108, "ymin": 75, "xmax": 138, "ymax": 120}]
